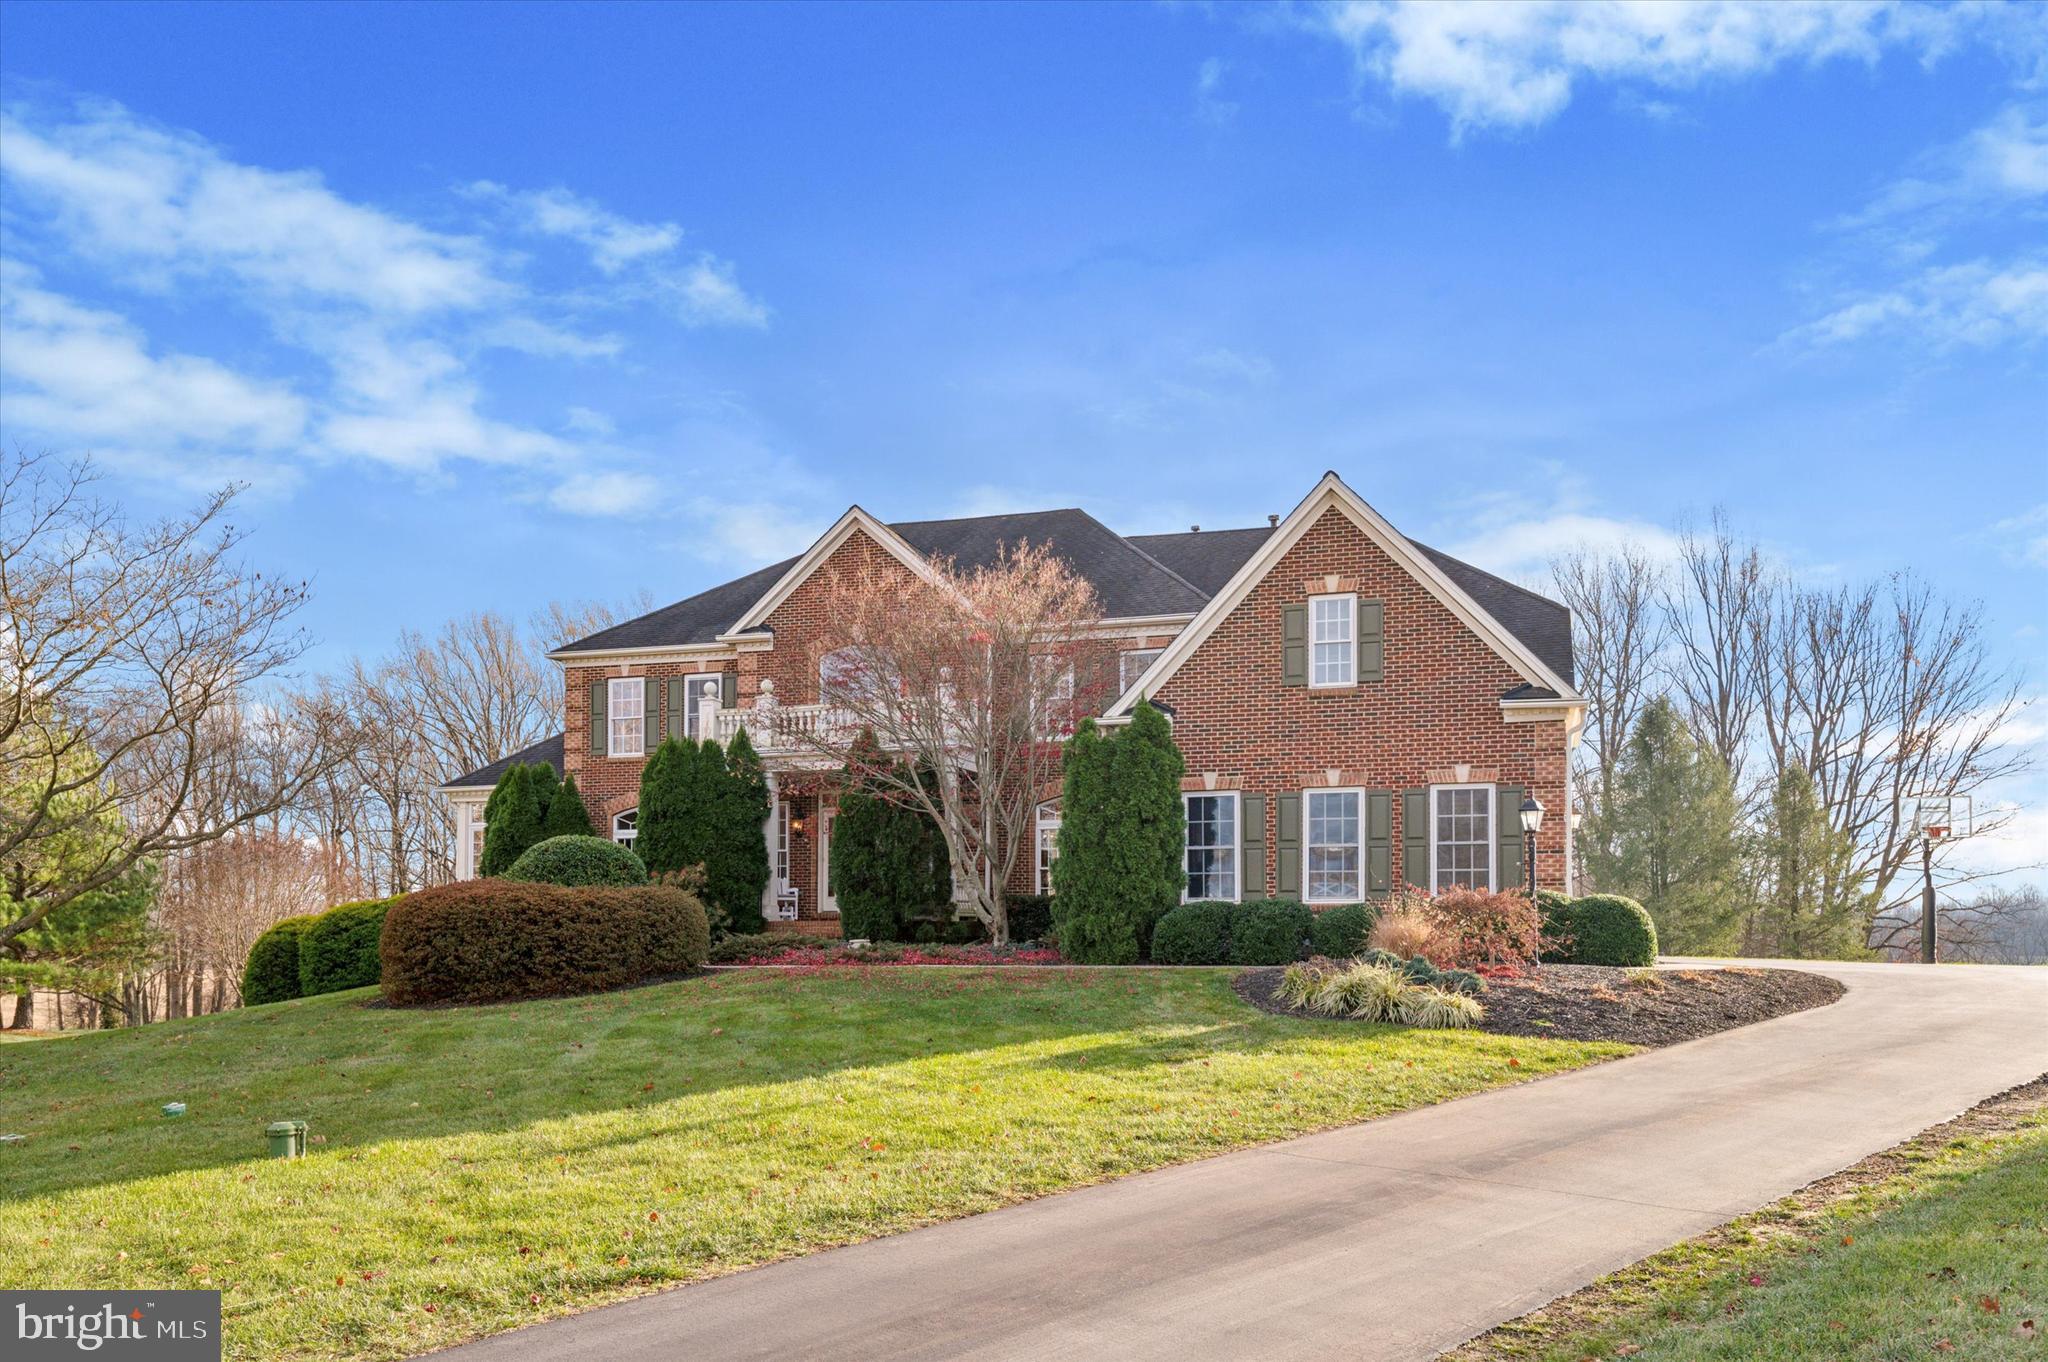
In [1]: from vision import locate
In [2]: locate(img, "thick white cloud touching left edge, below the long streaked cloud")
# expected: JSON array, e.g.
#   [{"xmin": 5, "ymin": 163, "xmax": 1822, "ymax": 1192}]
[{"xmin": 0, "ymin": 260, "xmax": 307, "ymax": 453}]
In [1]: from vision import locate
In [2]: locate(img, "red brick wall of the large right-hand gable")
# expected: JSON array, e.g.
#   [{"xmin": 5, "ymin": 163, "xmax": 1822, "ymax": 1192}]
[{"xmin": 1157, "ymin": 510, "xmax": 1567, "ymax": 895}]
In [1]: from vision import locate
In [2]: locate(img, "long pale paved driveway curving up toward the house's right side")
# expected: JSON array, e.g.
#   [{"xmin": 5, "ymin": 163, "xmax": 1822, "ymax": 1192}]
[{"xmin": 444, "ymin": 965, "xmax": 2048, "ymax": 1362}]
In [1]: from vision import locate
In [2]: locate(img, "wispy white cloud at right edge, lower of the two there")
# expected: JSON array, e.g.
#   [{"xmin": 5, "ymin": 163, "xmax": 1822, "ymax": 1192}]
[{"xmin": 1780, "ymin": 256, "xmax": 2048, "ymax": 350}]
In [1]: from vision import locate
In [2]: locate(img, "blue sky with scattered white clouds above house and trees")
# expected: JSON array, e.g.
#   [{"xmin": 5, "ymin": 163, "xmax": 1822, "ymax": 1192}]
[{"xmin": 0, "ymin": 2, "xmax": 2048, "ymax": 860}]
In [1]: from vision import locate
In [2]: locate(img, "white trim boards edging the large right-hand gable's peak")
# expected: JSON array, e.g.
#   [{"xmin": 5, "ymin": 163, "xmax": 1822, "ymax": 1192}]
[{"xmin": 1104, "ymin": 473, "xmax": 1583, "ymax": 719}]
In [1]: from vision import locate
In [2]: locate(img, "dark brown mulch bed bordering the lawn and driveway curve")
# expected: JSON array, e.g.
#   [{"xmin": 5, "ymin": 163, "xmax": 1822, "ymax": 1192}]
[{"xmin": 1237, "ymin": 965, "xmax": 1843, "ymax": 1045}]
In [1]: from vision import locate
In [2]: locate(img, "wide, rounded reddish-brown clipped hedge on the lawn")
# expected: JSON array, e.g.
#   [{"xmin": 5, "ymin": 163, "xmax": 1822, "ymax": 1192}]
[{"xmin": 379, "ymin": 879, "xmax": 711, "ymax": 1008}]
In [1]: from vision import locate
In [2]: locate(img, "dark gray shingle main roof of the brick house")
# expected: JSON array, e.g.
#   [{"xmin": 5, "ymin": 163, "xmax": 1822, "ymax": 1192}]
[{"xmin": 552, "ymin": 508, "xmax": 1573, "ymax": 684}]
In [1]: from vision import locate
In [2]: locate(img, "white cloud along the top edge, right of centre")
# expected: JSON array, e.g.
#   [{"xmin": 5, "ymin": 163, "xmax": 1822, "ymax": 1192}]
[{"xmin": 1305, "ymin": 0, "xmax": 2030, "ymax": 135}]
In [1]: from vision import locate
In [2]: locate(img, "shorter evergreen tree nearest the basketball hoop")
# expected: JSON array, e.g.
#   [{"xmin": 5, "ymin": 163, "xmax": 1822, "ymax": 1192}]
[{"xmin": 1743, "ymin": 766, "xmax": 1868, "ymax": 961}]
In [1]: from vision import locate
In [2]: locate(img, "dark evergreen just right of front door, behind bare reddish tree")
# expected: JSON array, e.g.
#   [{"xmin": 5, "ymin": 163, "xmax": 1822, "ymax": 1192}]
[{"xmin": 831, "ymin": 735, "xmax": 952, "ymax": 940}]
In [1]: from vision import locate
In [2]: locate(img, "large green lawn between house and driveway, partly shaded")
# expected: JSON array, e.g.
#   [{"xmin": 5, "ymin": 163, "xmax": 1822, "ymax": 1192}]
[{"xmin": 0, "ymin": 969, "xmax": 1626, "ymax": 1358}]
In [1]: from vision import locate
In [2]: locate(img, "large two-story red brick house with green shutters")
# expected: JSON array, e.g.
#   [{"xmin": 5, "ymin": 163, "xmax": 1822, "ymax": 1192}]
[{"xmin": 440, "ymin": 473, "xmax": 1585, "ymax": 922}]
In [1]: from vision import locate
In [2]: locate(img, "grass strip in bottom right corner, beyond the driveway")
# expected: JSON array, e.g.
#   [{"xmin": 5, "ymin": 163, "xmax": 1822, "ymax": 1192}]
[{"xmin": 1458, "ymin": 1112, "xmax": 2048, "ymax": 1362}]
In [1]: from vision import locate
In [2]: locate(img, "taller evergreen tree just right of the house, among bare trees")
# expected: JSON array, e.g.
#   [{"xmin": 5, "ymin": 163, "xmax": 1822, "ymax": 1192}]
[{"xmin": 1581, "ymin": 696, "xmax": 1743, "ymax": 954}]
